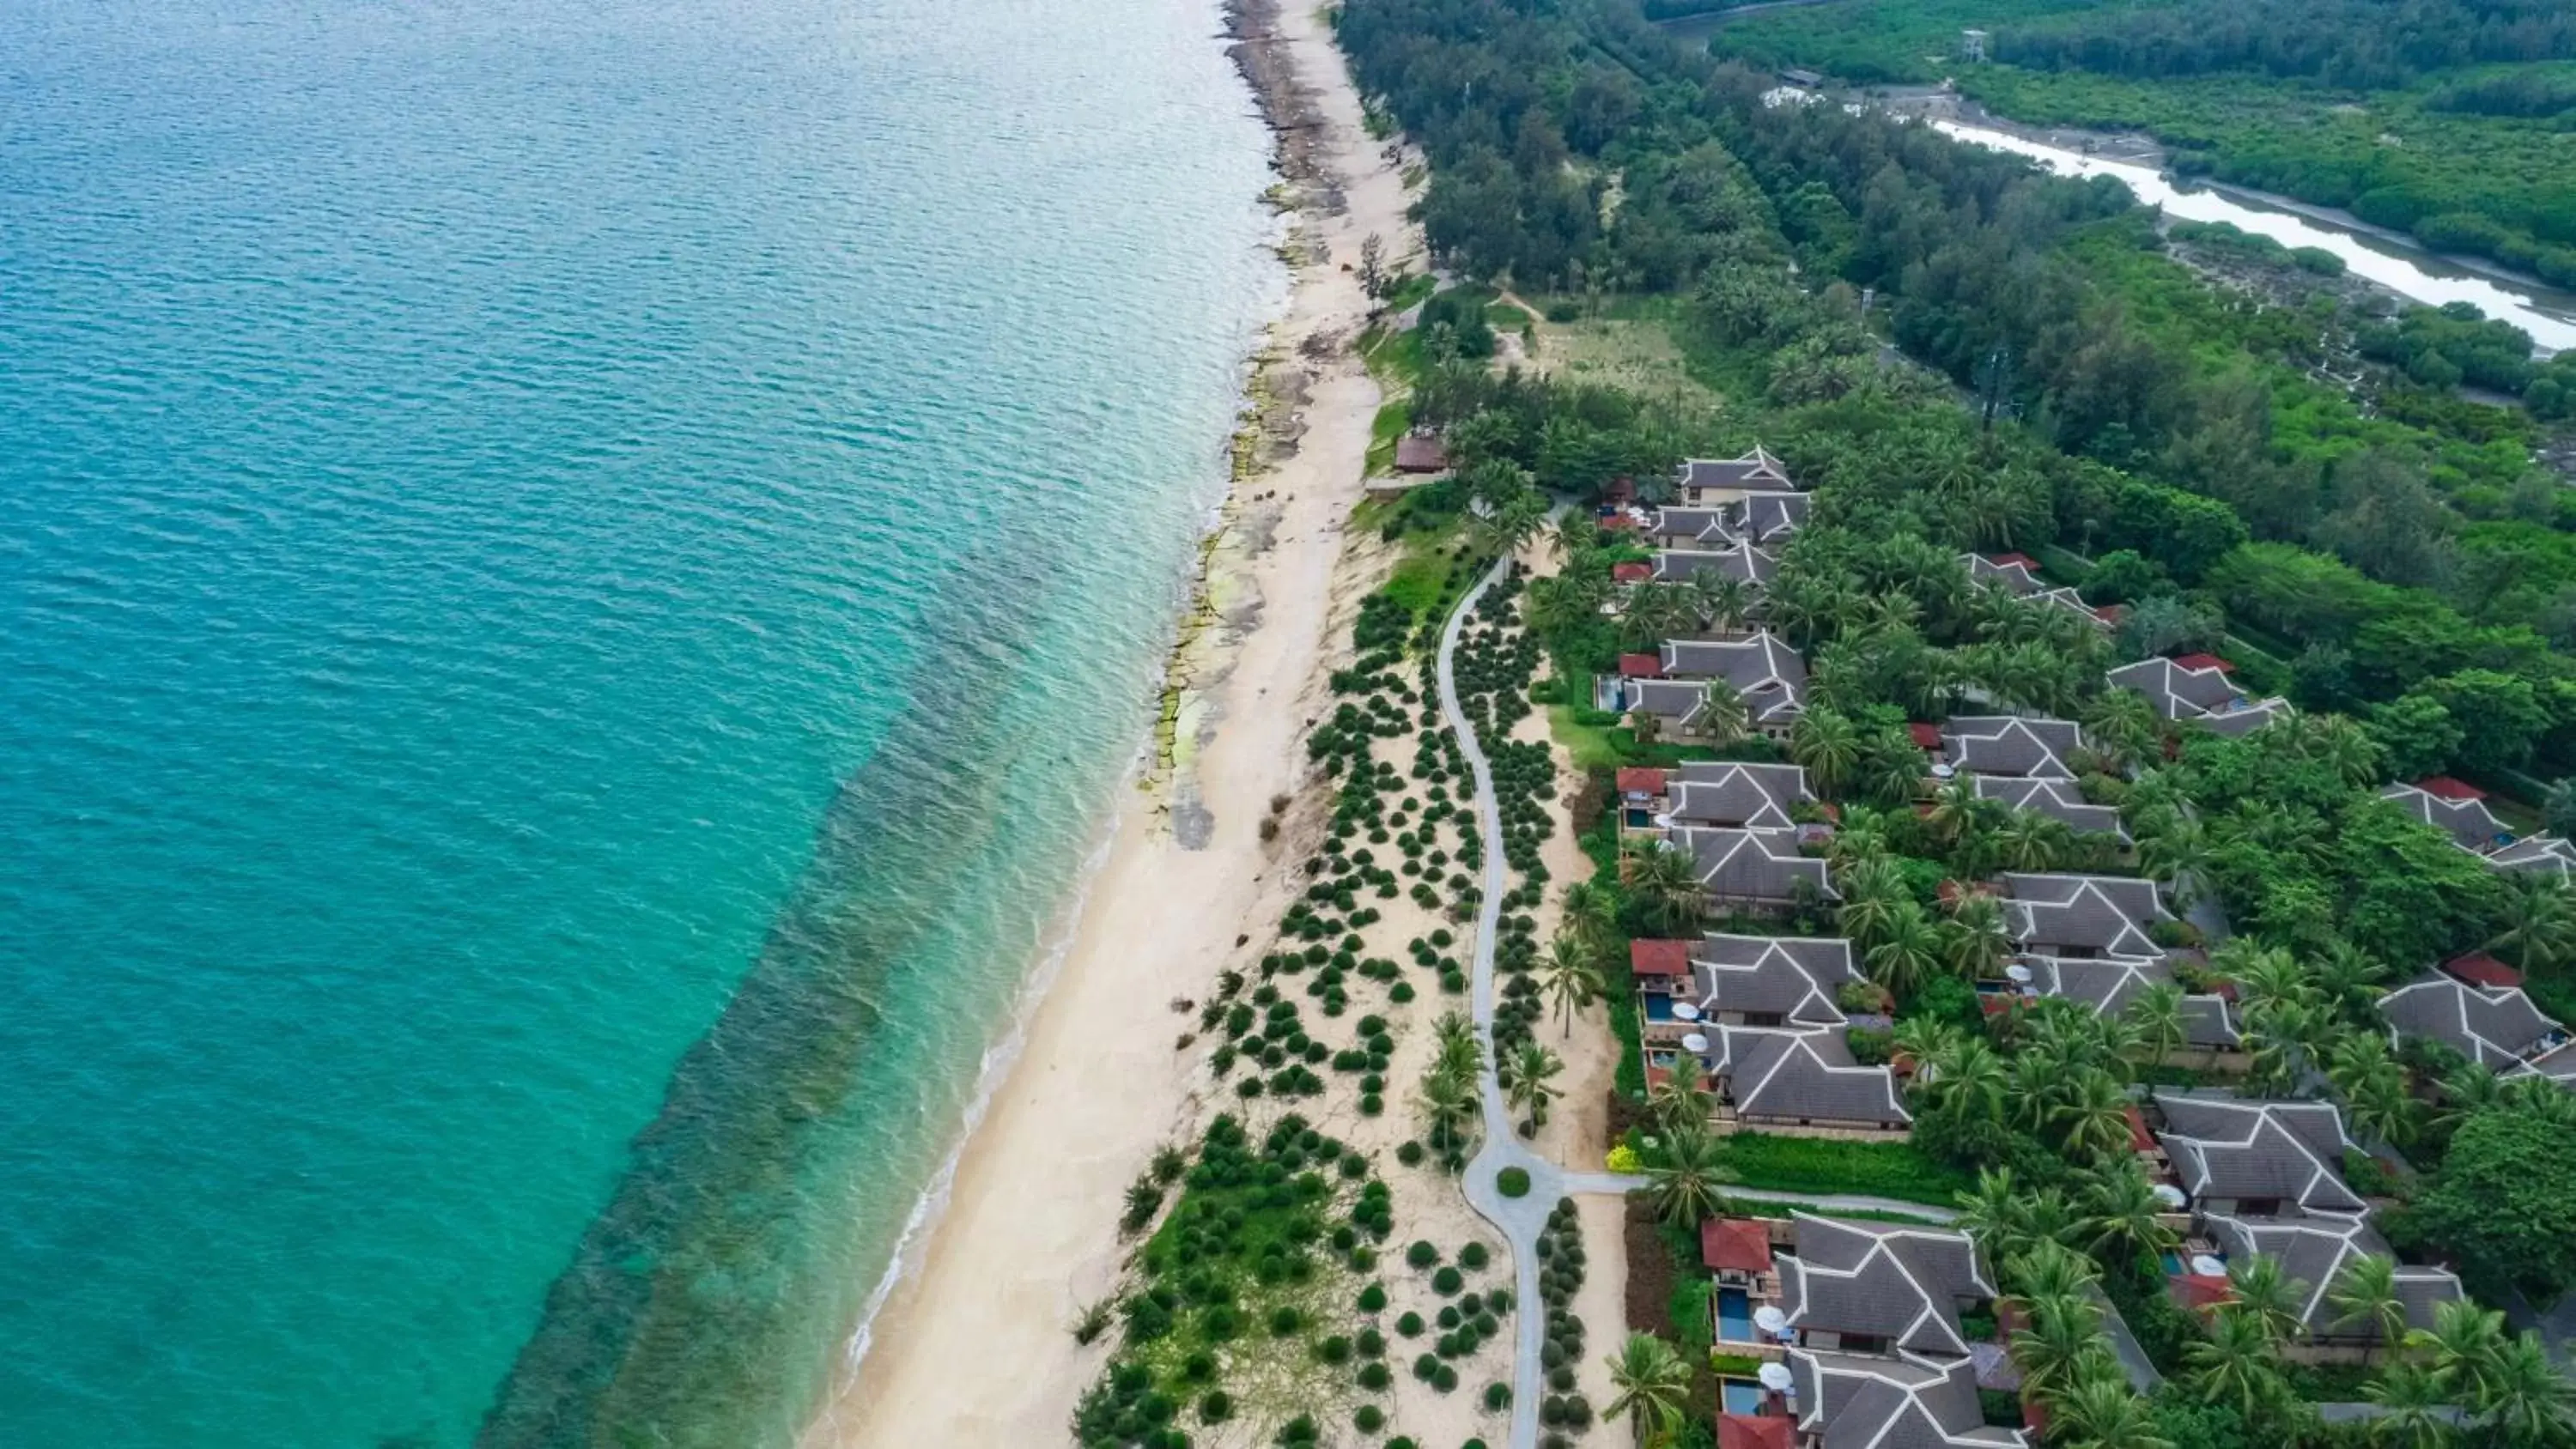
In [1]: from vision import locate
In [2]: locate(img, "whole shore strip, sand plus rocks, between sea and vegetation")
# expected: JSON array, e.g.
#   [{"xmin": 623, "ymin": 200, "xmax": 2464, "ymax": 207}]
[{"xmin": 801, "ymin": 0, "xmax": 1412, "ymax": 1449}]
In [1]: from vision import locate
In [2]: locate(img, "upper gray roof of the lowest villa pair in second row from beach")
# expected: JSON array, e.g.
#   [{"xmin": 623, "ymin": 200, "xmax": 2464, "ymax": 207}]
[{"xmin": 2156, "ymin": 1091, "xmax": 2365, "ymax": 1212}]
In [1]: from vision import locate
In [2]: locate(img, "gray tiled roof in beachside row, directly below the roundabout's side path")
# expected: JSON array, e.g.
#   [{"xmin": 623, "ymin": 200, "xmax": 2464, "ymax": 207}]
[{"xmin": 1777, "ymin": 1212, "xmax": 1994, "ymax": 1356}]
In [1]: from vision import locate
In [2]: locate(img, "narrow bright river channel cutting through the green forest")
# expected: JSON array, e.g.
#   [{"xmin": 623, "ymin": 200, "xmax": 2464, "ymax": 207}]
[{"xmin": 1929, "ymin": 118, "xmax": 2576, "ymax": 353}]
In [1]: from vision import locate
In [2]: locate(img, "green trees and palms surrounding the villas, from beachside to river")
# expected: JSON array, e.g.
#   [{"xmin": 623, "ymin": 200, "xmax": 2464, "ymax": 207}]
[{"xmin": 1309, "ymin": 0, "xmax": 2576, "ymax": 1446}]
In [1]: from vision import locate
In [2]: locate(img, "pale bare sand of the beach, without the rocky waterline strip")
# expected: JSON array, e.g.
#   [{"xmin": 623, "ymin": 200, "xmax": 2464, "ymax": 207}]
[{"xmin": 806, "ymin": 10, "xmax": 1422, "ymax": 1449}]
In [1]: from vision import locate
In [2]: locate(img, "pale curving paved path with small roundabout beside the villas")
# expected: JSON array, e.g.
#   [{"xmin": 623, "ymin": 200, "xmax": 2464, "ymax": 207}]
[{"xmin": 1440, "ymin": 559, "xmax": 1958, "ymax": 1449}]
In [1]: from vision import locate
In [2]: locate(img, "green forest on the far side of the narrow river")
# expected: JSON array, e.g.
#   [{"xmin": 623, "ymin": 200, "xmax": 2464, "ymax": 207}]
[{"xmin": 1716, "ymin": 0, "xmax": 2576, "ymax": 286}]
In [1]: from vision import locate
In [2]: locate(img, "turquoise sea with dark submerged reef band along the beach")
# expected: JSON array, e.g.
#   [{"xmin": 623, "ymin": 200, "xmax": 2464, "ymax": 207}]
[{"xmin": 0, "ymin": 0, "xmax": 1283, "ymax": 1449}]
